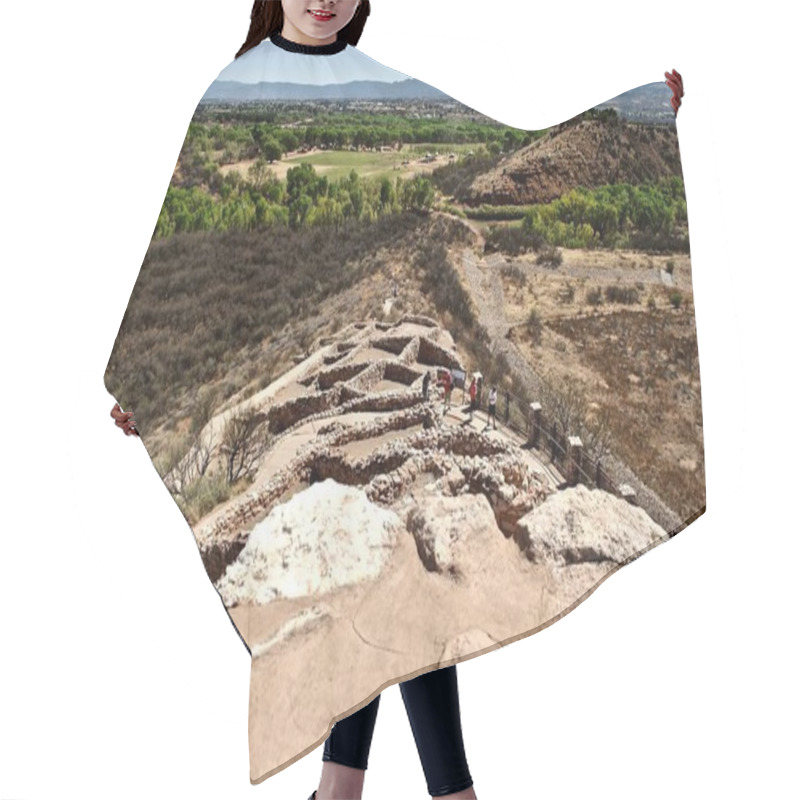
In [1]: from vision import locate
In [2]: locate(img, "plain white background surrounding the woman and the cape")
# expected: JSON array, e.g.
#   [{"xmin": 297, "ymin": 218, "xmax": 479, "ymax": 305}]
[{"xmin": 0, "ymin": 0, "xmax": 800, "ymax": 800}]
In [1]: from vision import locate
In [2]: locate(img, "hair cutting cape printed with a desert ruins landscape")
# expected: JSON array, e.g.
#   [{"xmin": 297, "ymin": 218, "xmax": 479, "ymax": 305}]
[{"xmin": 104, "ymin": 36, "xmax": 705, "ymax": 783}]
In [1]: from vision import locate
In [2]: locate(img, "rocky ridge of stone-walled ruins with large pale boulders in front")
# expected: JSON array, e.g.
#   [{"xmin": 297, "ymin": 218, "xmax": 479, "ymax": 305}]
[{"xmin": 180, "ymin": 315, "xmax": 666, "ymax": 612}]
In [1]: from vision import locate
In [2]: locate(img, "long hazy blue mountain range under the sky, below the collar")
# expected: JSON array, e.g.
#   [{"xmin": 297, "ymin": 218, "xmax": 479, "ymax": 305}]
[{"xmin": 200, "ymin": 78, "xmax": 450, "ymax": 103}]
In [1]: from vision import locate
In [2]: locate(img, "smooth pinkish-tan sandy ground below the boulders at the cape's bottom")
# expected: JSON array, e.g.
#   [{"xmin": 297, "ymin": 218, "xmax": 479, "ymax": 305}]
[{"xmin": 230, "ymin": 506, "xmax": 618, "ymax": 783}]
